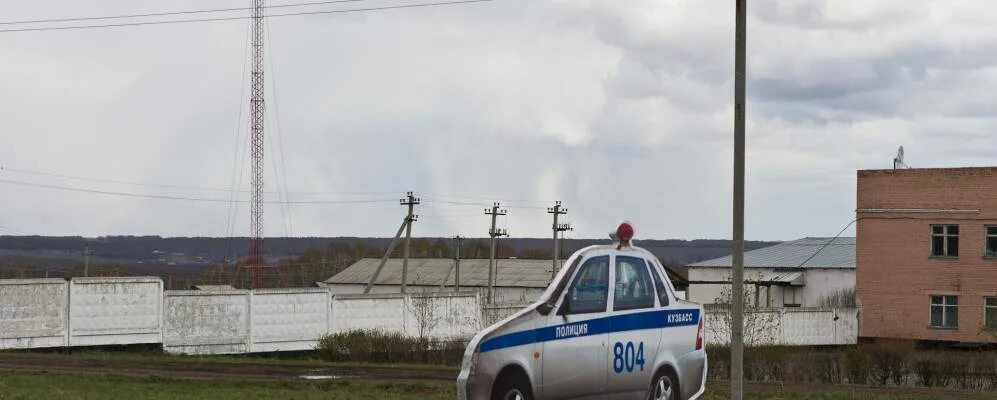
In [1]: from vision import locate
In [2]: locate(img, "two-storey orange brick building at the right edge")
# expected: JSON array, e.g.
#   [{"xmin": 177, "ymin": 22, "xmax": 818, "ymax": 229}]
[{"xmin": 855, "ymin": 167, "xmax": 997, "ymax": 343}]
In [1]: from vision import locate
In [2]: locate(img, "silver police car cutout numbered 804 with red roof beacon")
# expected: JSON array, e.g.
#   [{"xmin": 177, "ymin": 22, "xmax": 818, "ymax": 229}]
[{"xmin": 457, "ymin": 222, "xmax": 706, "ymax": 400}]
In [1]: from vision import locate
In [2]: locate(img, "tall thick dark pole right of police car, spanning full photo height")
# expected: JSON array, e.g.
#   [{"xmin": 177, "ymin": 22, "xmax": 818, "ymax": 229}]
[{"xmin": 730, "ymin": 0, "xmax": 747, "ymax": 400}]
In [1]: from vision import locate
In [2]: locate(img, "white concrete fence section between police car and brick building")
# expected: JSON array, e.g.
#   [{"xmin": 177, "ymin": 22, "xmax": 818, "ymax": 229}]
[{"xmin": 704, "ymin": 308, "xmax": 858, "ymax": 346}]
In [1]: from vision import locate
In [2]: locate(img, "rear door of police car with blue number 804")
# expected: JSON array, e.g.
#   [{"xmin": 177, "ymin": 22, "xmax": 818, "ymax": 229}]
[{"xmin": 607, "ymin": 255, "xmax": 665, "ymax": 399}]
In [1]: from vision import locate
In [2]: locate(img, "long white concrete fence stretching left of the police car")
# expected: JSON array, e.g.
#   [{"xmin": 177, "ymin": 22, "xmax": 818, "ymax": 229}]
[{"xmin": 0, "ymin": 277, "xmax": 482, "ymax": 354}]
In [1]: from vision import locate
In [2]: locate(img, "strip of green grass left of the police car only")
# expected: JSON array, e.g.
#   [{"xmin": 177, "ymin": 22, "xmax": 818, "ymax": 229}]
[{"xmin": 0, "ymin": 372, "xmax": 456, "ymax": 400}]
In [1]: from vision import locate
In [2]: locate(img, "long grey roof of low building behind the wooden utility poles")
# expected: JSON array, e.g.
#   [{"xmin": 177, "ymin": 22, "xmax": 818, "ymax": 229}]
[{"xmin": 325, "ymin": 258, "xmax": 551, "ymax": 288}]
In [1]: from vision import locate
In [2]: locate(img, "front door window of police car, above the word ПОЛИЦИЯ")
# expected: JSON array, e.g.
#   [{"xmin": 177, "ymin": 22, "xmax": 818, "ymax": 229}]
[{"xmin": 558, "ymin": 256, "xmax": 609, "ymax": 314}]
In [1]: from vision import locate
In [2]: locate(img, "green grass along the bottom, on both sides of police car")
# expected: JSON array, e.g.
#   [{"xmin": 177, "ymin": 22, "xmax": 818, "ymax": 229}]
[{"xmin": 0, "ymin": 372, "xmax": 988, "ymax": 400}]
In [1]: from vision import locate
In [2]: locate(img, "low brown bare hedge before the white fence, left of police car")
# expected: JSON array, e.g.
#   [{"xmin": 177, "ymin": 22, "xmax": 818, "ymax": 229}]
[{"xmin": 315, "ymin": 330, "xmax": 466, "ymax": 365}]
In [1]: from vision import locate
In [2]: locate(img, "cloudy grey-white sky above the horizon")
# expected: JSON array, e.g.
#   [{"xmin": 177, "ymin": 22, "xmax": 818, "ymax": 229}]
[{"xmin": 0, "ymin": 0, "xmax": 997, "ymax": 240}]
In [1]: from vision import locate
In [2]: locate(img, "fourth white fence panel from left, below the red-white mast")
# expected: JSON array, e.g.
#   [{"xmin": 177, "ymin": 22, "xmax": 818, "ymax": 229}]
[{"xmin": 250, "ymin": 288, "xmax": 332, "ymax": 352}]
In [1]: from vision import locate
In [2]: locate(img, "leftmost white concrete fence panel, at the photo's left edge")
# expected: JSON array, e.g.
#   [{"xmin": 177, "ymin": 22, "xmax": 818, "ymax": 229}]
[{"xmin": 0, "ymin": 279, "xmax": 69, "ymax": 349}]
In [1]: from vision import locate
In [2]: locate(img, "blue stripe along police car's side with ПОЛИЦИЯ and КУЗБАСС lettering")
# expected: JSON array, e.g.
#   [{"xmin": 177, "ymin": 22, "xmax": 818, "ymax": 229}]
[{"xmin": 480, "ymin": 309, "xmax": 699, "ymax": 353}]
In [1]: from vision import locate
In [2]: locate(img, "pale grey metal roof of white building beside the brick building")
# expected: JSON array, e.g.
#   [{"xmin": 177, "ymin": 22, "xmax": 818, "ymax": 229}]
[{"xmin": 688, "ymin": 237, "xmax": 855, "ymax": 268}]
